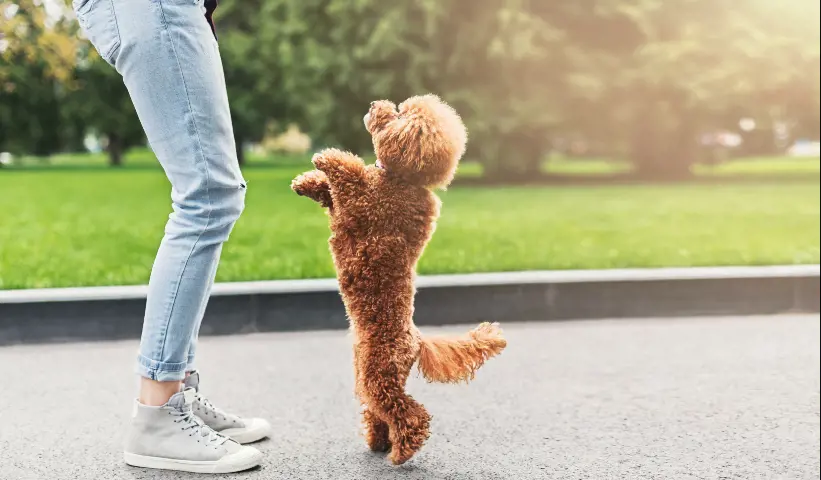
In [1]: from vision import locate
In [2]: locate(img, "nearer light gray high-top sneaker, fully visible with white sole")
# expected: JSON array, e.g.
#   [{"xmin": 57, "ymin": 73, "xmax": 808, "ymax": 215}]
[{"xmin": 123, "ymin": 388, "xmax": 262, "ymax": 473}]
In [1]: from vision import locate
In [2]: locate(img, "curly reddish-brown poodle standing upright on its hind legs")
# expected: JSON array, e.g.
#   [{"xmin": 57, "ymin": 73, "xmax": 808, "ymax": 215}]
[{"xmin": 291, "ymin": 95, "xmax": 507, "ymax": 465}]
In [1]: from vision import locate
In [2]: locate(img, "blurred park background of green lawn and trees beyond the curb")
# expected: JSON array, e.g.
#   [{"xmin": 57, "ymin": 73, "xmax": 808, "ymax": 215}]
[{"xmin": 0, "ymin": 0, "xmax": 821, "ymax": 289}]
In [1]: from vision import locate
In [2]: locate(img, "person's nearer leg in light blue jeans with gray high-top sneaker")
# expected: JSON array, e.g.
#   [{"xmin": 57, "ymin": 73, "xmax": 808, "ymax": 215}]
[{"xmin": 74, "ymin": 0, "xmax": 261, "ymax": 473}]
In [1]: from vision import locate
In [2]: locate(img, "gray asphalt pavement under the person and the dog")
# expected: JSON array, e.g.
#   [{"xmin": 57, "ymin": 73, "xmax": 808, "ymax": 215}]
[{"xmin": 0, "ymin": 315, "xmax": 820, "ymax": 480}]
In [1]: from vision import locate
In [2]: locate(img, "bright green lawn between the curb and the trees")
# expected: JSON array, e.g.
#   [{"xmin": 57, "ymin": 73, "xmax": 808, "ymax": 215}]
[{"xmin": 0, "ymin": 167, "xmax": 820, "ymax": 289}]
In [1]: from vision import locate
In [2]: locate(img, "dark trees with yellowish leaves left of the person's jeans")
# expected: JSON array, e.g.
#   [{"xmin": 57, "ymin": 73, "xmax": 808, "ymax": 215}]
[{"xmin": 0, "ymin": 0, "xmax": 143, "ymax": 166}]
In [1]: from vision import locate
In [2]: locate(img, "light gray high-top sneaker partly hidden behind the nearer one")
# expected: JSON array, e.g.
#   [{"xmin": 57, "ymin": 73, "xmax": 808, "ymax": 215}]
[{"xmin": 185, "ymin": 371, "xmax": 271, "ymax": 444}]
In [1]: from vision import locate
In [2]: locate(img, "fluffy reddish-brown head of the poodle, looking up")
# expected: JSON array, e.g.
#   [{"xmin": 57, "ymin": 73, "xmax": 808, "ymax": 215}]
[{"xmin": 365, "ymin": 95, "xmax": 467, "ymax": 188}]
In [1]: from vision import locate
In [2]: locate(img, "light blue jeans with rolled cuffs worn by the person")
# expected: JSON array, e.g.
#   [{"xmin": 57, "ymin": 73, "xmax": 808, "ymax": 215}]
[{"xmin": 73, "ymin": 0, "xmax": 246, "ymax": 381}]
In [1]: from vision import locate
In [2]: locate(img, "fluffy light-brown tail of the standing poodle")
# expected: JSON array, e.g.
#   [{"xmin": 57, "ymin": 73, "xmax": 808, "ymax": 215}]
[{"xmin": 419, "ymin": 323, "xmax": 507, "ymax": 383}]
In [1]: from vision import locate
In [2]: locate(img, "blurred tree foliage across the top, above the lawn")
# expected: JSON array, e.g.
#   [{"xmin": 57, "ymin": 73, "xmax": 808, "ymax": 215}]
[{"xmin": 0, "ymin": 0, "xmax": 821, "ymax": 178}]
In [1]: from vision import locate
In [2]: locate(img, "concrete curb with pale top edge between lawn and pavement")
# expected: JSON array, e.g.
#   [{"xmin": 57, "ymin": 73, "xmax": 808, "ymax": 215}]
[{"xmin": 0, "ymin": 265, "xmax": 821, "ymax": 345}]
